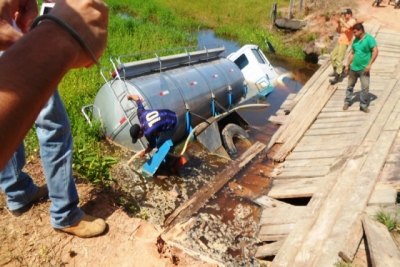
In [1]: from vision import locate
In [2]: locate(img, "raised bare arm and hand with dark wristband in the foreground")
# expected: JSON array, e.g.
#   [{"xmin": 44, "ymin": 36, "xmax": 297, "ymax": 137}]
[{"xmin": 0, "ymin": 0, "xmax": 108, "ymax": 169}]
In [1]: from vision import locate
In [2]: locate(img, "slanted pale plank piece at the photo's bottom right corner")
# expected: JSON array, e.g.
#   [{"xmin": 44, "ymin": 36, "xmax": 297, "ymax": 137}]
[{"xmin": 362, "ymin": 217, "xmax": 400, "ymax": 267}]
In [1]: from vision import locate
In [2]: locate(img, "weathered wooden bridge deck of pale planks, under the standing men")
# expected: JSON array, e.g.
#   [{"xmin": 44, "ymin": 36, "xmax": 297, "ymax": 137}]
[{"xmin": 257, "ymin": 25, "xmax": 400, "ymax": 266}]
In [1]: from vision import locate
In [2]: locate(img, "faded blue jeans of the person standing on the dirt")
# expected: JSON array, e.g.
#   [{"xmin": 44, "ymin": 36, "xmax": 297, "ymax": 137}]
[{"xmin": 0, "ymin": 91, "xmax": 84, "ymax": 228}]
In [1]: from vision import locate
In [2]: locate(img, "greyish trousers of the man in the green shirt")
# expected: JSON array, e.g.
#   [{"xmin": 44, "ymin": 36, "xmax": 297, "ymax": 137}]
[{"xmin": 344, "ymin": 70, "xmax": 370, "ymax": 109}]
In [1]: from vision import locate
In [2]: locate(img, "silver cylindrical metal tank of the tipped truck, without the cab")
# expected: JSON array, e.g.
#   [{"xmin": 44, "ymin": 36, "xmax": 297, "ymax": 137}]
[{"xmin": 93, "ymin": 54, "xmax": 246, "ymax": 151}]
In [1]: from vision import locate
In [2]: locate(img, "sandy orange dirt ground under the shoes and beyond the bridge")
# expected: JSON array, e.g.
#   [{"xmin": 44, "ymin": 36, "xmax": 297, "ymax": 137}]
[{"xmin": 0, "ymin": 0, "xmax": 400, "ymax": 267}]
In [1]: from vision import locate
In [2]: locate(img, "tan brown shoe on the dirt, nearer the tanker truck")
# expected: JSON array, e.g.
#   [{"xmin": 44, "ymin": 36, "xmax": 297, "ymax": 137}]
[{"xmin": 56, "ymin": 214, "xmax": 107, "ymax": 238}]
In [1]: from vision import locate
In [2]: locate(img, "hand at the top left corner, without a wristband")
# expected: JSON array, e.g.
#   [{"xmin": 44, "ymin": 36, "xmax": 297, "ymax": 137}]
[{"xmin": 0, "ymin": 0, "xmax": 38, "ymax": 50}]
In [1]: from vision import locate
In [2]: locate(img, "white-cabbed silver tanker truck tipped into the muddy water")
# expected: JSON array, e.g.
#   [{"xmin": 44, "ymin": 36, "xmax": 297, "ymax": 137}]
[{"xmin": 82, "ymin": 45, "xmax": 277, "ymax": 175}]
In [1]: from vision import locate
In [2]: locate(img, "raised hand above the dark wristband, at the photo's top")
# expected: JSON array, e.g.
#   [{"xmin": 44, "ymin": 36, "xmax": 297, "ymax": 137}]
[{"xmin": 50, "ymin": 0, "xmax": 108, "ymax": 68}]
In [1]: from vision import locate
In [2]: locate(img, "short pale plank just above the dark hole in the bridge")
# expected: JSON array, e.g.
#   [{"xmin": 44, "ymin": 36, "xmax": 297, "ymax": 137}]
[{"xmin": 268, "ymin": 178, "xmax": 324, "ymax": 199}]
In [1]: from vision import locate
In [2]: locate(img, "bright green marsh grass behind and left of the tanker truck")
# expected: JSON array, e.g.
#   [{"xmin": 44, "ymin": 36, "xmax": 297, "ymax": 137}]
[{"xmin": 25, "ymin": 0, "xmax": 302, "ymax": 184}]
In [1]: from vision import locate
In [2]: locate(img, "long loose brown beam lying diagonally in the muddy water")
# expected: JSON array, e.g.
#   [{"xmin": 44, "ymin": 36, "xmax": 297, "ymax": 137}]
[{"xmin": 164, "ymin": 142, "xmax": 265, "ymax": 232}]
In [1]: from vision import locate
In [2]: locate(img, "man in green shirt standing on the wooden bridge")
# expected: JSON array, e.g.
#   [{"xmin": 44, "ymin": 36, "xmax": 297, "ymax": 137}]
[{"xmin": 343, "ymin": 23, "xmax": 378, "ymax": 113}]
